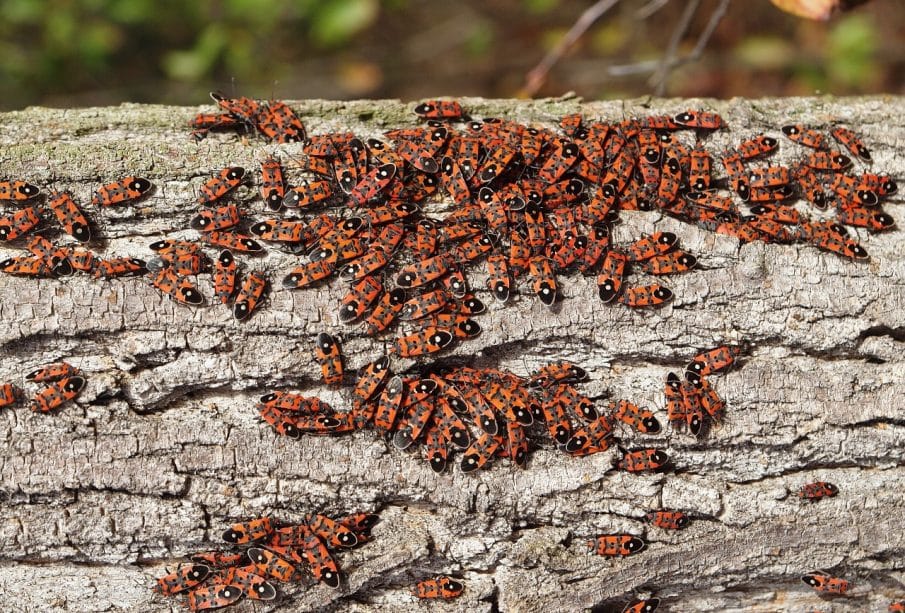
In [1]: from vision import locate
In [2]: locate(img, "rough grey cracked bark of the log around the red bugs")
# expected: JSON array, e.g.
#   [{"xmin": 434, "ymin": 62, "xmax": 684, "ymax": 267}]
[{"xmin": 0, "ymin": 98, "xmax": 905, "ymax": 613}]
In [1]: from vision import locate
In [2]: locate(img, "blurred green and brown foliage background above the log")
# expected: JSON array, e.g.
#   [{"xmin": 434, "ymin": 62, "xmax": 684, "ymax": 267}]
[{"xmin": 0, "ymin": 0, "xmax": 905, "ymax": 109}]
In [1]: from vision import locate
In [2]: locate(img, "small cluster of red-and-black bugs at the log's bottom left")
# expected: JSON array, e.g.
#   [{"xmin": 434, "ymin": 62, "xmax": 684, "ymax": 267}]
[{"xmin": 155, "ymin": 513, "xmax": 379, "ymax": 611}]
